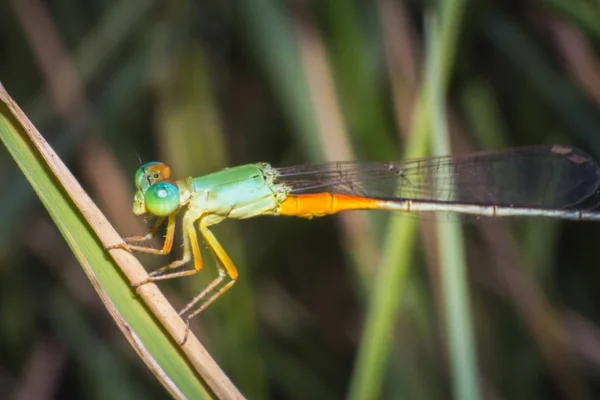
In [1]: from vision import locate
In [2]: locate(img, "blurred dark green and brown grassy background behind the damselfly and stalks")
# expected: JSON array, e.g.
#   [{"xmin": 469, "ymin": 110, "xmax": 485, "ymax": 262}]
[{"xmin": 0, "ymin": 0, "xmax": 600, "ymax": 399}]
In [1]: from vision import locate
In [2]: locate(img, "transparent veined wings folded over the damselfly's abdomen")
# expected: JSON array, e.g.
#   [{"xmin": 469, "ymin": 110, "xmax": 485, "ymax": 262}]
[{"xmin": 276, "ymin": 146, "xmax": 600, "ymax": 208}]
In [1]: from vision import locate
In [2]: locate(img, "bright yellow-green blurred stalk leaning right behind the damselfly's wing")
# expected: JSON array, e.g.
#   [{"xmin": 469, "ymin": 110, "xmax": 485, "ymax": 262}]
[{"xmin": 349, "ymin": 0, "xmax": 464, "ymax": 399}]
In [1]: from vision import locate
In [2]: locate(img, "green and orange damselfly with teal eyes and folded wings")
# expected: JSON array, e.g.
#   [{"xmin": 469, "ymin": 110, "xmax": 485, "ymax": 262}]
[{"xmin": 112, "ymin": 145, "xmax": 600, "ymax": 342}]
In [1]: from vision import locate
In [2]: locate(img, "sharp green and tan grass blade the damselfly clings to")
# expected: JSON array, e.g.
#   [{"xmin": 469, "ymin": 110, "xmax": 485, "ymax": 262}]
[{"xmin": 0, "ymin": 86, "xmax": 241, "ymax": 398}]
